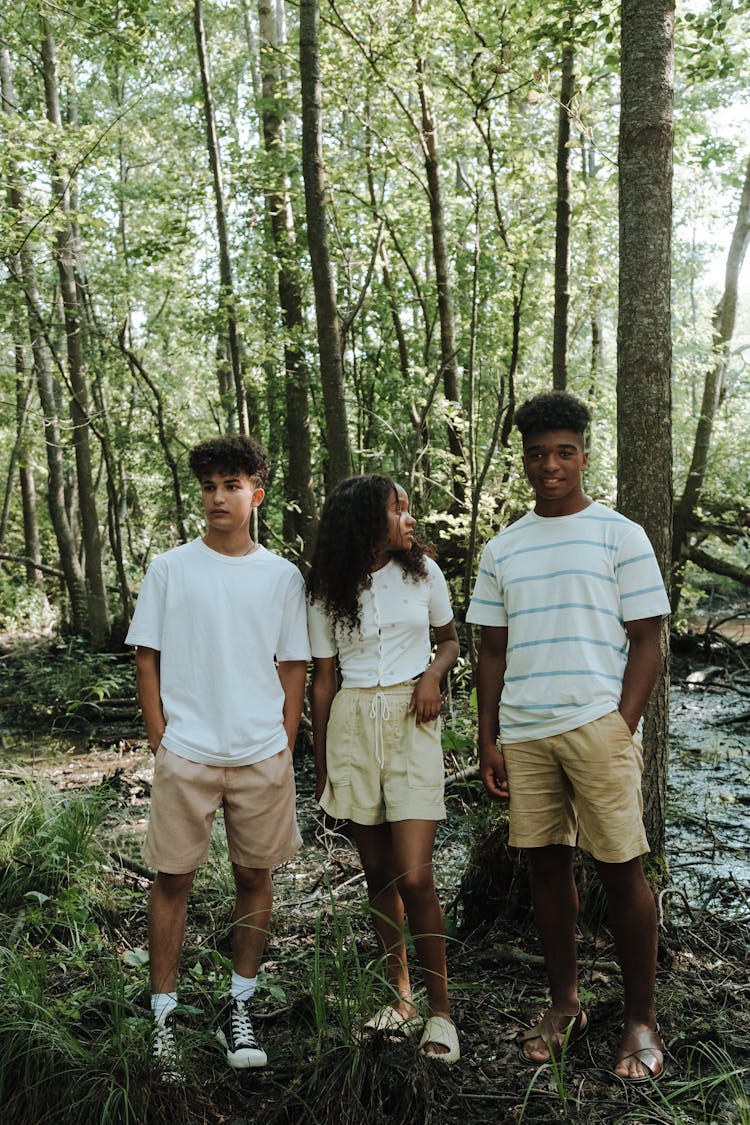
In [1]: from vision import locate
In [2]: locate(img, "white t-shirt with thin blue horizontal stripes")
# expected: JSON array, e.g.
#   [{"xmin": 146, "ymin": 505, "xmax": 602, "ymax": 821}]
[{"xmin": 467, "ymin": 503, "xmax": 670, "ymax": 743}]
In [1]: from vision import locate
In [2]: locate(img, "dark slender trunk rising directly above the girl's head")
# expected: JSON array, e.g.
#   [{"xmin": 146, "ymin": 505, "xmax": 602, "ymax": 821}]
[{"xmin": 299, "ymin": 0, "xmax": 352, "ymax": 485}]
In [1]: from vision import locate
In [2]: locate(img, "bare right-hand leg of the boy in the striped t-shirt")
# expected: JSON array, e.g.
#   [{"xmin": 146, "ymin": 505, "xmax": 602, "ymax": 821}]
[{"xmin": 596, "ymin": 858, "xmax": 658, "ymax": 1079}]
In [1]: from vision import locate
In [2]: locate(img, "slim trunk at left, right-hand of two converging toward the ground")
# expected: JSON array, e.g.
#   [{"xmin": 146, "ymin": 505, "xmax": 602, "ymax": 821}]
[{"xmin": 42, "ymin": 20, "xmax": 109, "ymax": 648}]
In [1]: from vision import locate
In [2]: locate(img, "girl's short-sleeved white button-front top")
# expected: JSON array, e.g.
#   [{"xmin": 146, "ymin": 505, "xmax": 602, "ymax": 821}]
[{"xmin": 308, "ymin": 557, "xmax": 453, "ymax": 687}]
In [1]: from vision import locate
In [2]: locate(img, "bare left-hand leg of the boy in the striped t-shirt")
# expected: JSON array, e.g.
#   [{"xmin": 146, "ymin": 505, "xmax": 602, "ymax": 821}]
[{"xmin": 523, "ymin": 844, "xmax": 578, "ymax": 1062}]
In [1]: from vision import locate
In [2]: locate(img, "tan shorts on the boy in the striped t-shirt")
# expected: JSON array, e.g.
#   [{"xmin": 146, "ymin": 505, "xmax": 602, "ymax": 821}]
[{"xmin": 503, "ymin": 711, "xmax": 649, "ymax": 863}]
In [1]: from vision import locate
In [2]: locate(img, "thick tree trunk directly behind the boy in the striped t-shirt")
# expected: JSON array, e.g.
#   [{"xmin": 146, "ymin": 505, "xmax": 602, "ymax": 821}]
[{"xmin": 617, "ymin": 0, "xmax": 675, "ymax": 861}]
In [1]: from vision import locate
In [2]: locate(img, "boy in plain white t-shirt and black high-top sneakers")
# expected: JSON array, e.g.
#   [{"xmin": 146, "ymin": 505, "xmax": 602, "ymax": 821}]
[{"xmin": 126, "ymin": 435, "xmax": 309, "ymax": 1074}]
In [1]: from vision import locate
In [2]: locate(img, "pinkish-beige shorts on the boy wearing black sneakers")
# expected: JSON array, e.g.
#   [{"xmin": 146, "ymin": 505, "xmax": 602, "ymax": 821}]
[{"xmin": 143, "ymin": 746, "xmax": 301, "ymax": 875}]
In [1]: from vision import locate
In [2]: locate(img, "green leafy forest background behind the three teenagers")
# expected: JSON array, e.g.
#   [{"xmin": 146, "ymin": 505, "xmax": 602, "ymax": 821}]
[{"xmin": 0, "ymin": 0, "xmax": 750, "ymax": 646}]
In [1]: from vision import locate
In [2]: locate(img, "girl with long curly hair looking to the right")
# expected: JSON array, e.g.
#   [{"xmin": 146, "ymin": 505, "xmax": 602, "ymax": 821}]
[{"xmin": 308, "ymin": 474, "xmax": 460, "ymax": 1063}]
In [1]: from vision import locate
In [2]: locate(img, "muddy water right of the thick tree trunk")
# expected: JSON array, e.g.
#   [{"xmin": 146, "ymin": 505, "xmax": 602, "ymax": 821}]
[{"xmin": 667, "ymin": 669, "xmax": 750, "ymax": 914}]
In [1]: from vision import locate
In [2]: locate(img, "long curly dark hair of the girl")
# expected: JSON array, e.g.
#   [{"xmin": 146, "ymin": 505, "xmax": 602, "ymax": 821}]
[{"xmin": 307, "ymin": 473, "xmax": 427, "ymax": 632}]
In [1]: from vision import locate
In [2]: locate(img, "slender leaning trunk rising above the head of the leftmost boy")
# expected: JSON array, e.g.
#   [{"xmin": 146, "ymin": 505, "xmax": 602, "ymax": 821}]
[{"xmin": 192, "ymin": 0, "xmax": 250, "ymax": 433}]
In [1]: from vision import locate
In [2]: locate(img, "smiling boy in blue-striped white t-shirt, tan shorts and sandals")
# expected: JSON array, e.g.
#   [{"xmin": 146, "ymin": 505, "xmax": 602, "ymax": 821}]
[{"xmin": 467, "ymin": 392, "xmax": 669, "ymax": 1083}]
